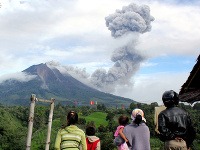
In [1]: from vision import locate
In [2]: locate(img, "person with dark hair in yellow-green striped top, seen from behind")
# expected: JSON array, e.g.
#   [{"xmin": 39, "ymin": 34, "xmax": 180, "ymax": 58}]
[{"xmin": 54, "ymin": 111, "xmax": 87, "ymax": 150}]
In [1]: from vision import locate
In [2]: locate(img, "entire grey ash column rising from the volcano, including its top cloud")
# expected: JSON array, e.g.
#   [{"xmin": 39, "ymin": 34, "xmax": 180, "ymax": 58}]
[{"xmin": 91, "ymin": 3, "xmax": 154, "ymax": 92}]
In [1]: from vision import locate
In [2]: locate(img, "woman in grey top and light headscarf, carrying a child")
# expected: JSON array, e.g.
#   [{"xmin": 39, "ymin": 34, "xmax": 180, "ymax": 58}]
[{"xmin": 123, "ymin": 108, "xmax": 151, "ymax": 150}]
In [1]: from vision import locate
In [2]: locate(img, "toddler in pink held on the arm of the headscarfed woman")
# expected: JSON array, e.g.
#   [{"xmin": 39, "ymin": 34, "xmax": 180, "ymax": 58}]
[{"xmin": 114, "ymin": 116, "xmax": 129, "ymax": 150}]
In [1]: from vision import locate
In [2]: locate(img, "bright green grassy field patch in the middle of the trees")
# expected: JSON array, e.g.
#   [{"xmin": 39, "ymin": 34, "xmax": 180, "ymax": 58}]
[{"xmin": 80, "ymin": 112, "xmax": 108, "ymax": 127}]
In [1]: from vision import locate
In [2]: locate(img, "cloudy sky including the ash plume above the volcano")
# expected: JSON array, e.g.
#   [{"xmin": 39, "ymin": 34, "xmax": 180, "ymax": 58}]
[{"xmin": 0, "ymin": 0, "xmax": 200, "ymax": 104}]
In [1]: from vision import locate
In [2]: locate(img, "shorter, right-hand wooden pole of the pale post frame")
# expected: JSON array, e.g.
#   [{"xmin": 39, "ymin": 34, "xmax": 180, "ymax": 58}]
[{"xmin": 45, "ymin": 99, "xmax": 54, "ymax": 150}]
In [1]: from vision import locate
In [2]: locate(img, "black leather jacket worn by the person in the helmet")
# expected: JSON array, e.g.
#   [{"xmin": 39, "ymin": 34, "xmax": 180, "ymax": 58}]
[{"xmin": 158, "ymin": 107, "xmax": 196, "ymax": 145}]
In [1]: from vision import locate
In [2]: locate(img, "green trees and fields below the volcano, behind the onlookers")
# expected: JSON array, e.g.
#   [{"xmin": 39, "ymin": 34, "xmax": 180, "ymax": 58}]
[{"xmin": 0, "ymin": 102, "xmax": 200, "ymax": 150}]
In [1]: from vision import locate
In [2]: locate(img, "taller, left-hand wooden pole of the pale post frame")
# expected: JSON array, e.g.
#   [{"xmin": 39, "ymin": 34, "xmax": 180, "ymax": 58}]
[{"xmin": 26, "ymin": 94, "xmax": 36, "ymax": 150}]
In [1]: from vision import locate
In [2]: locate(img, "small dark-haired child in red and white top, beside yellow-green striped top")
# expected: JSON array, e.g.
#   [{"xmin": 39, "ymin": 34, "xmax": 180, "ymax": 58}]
[{"xmin": 86, "ymin": 126, "xmax": 101, "ymax": 150}]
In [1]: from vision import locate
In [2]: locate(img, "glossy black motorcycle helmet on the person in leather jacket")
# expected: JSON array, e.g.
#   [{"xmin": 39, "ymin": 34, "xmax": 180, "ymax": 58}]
[{"xmin": 162, "ymin": 90, "xmax": 179, "ymax": 107}]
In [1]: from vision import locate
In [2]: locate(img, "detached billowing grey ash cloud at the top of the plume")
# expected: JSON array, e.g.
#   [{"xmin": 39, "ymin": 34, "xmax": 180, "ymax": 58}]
[{"xmin": 105, "ymin": 3, "xmax": 154, "ymax": 38}]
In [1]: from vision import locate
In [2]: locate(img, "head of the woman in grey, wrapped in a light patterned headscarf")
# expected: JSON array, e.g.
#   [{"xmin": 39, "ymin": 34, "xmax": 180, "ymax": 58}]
[{"xmin": 131, "ymin": 108, "xmax": 146, "ymax": 125}]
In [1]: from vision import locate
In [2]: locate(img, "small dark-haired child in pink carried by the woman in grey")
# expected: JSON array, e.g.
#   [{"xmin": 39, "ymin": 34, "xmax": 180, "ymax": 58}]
[{"xmin": 114, "ymin": 115, "xmax": 129, "ymax": 150}]
